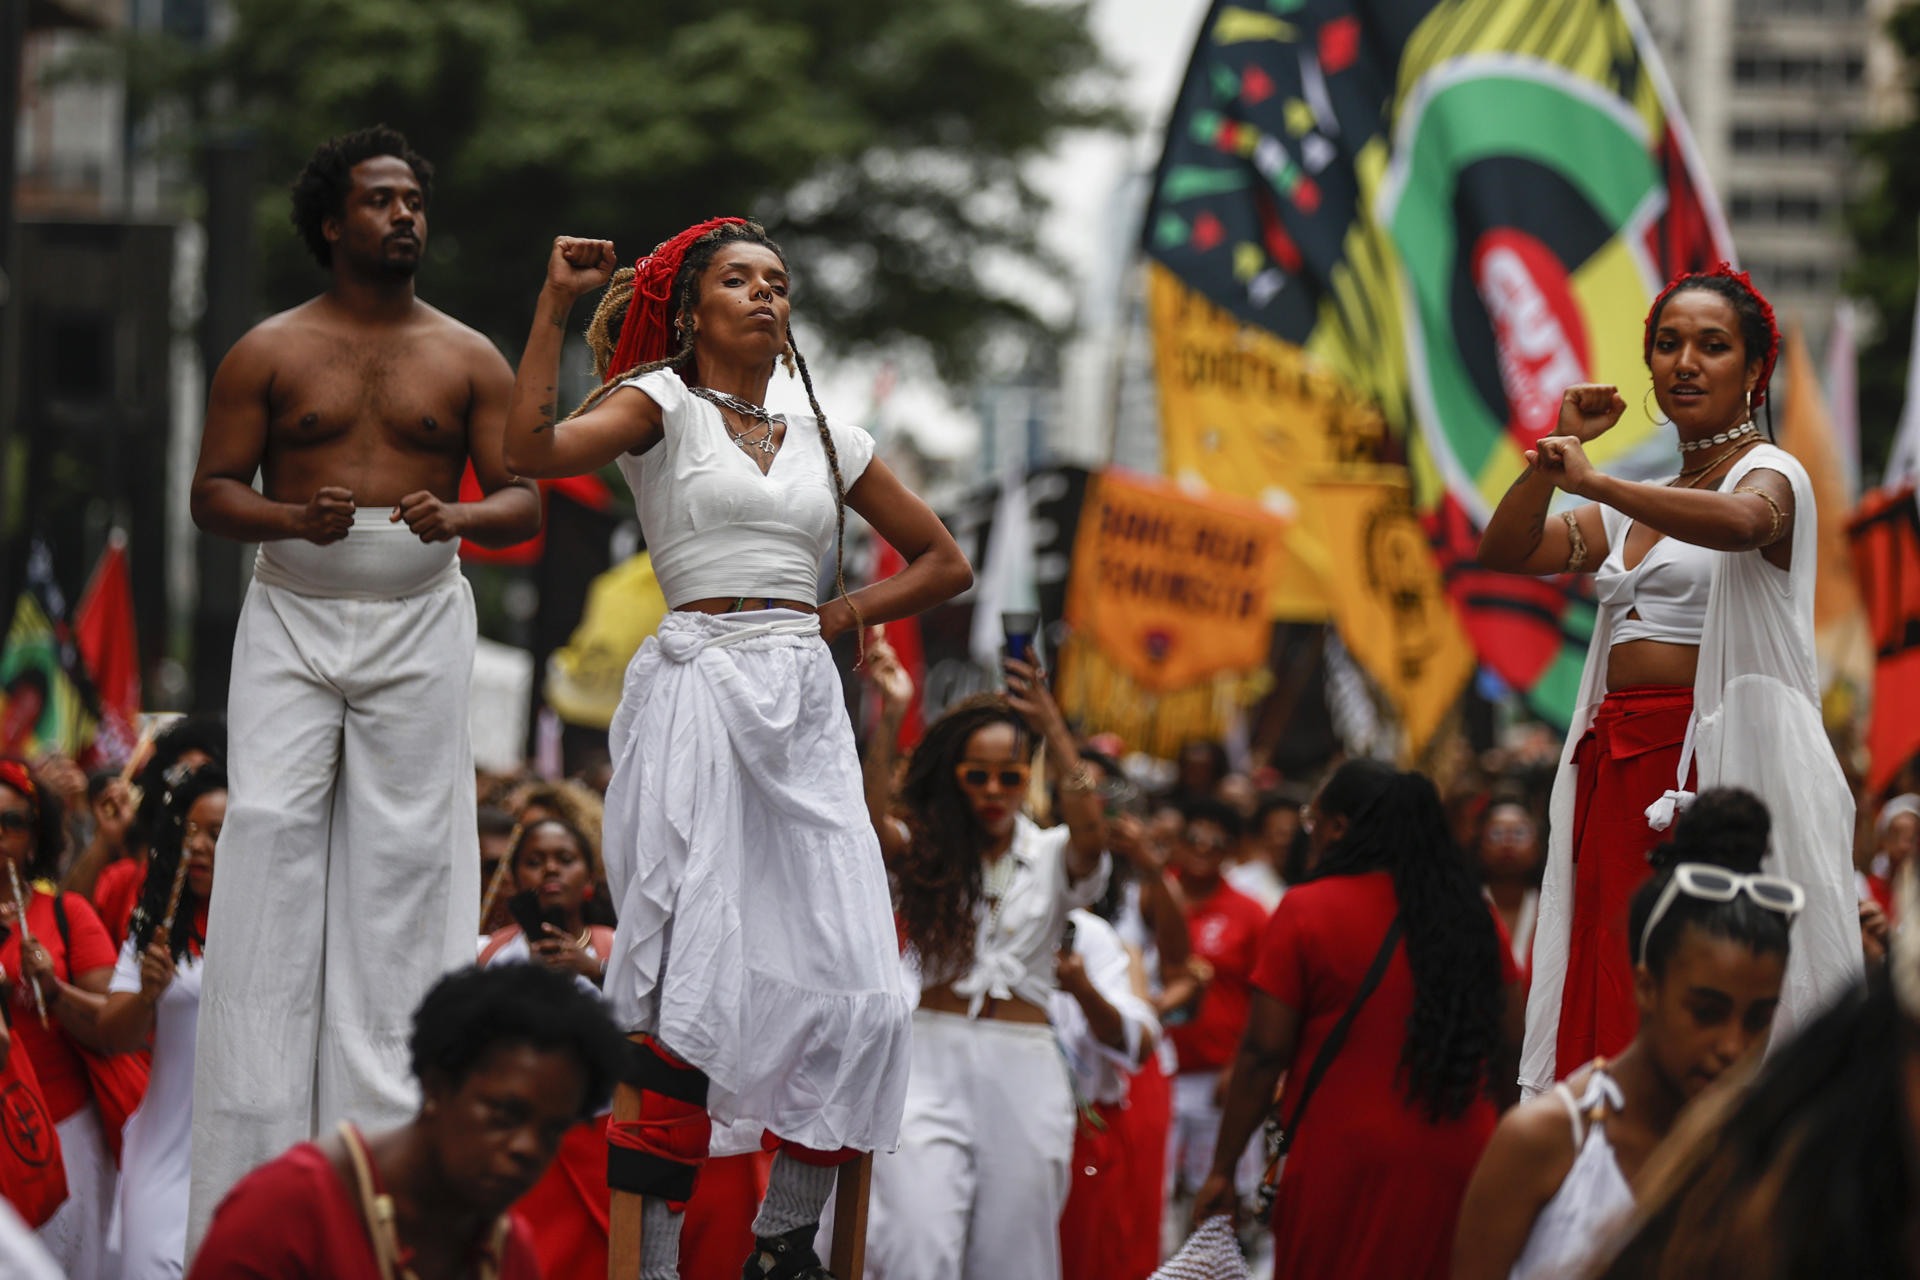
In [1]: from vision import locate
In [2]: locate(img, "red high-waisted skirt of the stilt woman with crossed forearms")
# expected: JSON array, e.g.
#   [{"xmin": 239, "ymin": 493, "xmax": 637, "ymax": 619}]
[{"xmin": 1553, "ymin": 685, "xmax": 1693, "ymax": 1077}]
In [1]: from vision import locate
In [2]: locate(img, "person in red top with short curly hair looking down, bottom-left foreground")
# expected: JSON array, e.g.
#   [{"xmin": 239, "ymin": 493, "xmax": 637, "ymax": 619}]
[{"xmin": 188, "ymin": 965, "xmax": 626, "ymax": 1280}]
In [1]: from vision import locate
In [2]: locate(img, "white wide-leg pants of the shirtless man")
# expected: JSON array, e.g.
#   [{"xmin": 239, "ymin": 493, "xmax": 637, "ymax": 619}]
[{"xmin": 188, "ymin": 510, "xmax": 480, "ymax": 1255}]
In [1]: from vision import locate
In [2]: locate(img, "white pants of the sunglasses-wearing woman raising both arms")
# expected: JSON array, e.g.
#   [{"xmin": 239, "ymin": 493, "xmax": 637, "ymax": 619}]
[{"xmin": 868, "ymin": 1009, "xmax": 1075, "ymax": 1280}]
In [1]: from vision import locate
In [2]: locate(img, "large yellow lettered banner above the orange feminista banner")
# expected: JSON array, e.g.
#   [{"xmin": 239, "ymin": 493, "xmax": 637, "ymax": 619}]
[{"xmin": 1146, "ymin": 263, "xmax": 1386, "ymax": 622}]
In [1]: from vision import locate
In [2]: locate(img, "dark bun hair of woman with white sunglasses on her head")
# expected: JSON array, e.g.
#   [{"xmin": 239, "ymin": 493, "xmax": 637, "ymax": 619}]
[{"xmin": 1626, "ymin": 787, "xmax": 1791, "ymax": 977}]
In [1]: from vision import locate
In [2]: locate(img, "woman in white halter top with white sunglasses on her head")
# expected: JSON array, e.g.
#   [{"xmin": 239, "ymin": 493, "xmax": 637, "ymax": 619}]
[{"xmin": 1453, "ymin": 789, "xmax": 1807, "ymax": 1280}]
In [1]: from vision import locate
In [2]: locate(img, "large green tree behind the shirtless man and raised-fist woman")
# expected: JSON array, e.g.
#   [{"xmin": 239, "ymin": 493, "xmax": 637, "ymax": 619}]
[{"xmin": 153, "ymin": 0, "xmax": 1121, "ymax": 376}]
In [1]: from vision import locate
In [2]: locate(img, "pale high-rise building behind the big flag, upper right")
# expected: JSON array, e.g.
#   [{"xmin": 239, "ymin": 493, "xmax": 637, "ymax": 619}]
[{"xmin": 1642, "ymin": 0, "xmax": 1901, "ymax": 349}]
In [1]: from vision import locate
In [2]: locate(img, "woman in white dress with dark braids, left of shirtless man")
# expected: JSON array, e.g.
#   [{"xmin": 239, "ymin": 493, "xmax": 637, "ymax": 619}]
[{"xmin": 100, "ymin": 764, "xmax": 227, "ymax": 1280}]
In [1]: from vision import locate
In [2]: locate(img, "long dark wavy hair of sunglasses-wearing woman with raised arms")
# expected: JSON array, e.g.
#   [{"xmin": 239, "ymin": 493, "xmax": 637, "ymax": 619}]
[{"xmin": 893, "ymin": 693, "xmax": 1033, "ymax": 983}]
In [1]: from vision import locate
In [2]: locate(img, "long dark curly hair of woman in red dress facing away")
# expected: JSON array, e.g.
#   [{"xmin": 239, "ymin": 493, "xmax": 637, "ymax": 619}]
[{"xmin": 1311, "ymin": 760, "xmax": 1505, "ymax": 1123}]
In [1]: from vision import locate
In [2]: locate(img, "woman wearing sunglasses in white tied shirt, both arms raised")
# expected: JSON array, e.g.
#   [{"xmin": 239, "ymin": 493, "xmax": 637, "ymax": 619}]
[{"xmin": 866, "ymin": 654, "xmax": 1108, "ymax": 1280}]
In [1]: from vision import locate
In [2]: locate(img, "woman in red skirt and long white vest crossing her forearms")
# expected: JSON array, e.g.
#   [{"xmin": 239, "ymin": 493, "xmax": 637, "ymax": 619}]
[{"xmin": 1480, "ymin": 263, "xmax": 1860, "ymax": 1094}]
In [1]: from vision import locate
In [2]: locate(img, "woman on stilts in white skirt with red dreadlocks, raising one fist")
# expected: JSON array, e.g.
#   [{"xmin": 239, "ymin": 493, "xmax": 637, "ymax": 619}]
[{"xmin": 505, "ymin": 219, "xmax": 972, "ymax": 1280}]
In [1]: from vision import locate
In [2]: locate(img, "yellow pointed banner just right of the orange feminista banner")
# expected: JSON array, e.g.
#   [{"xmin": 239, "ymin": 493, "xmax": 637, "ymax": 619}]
[{"xmin": 1313, "ymin": 479, "xmax": 1475, "ymax": 756}]
